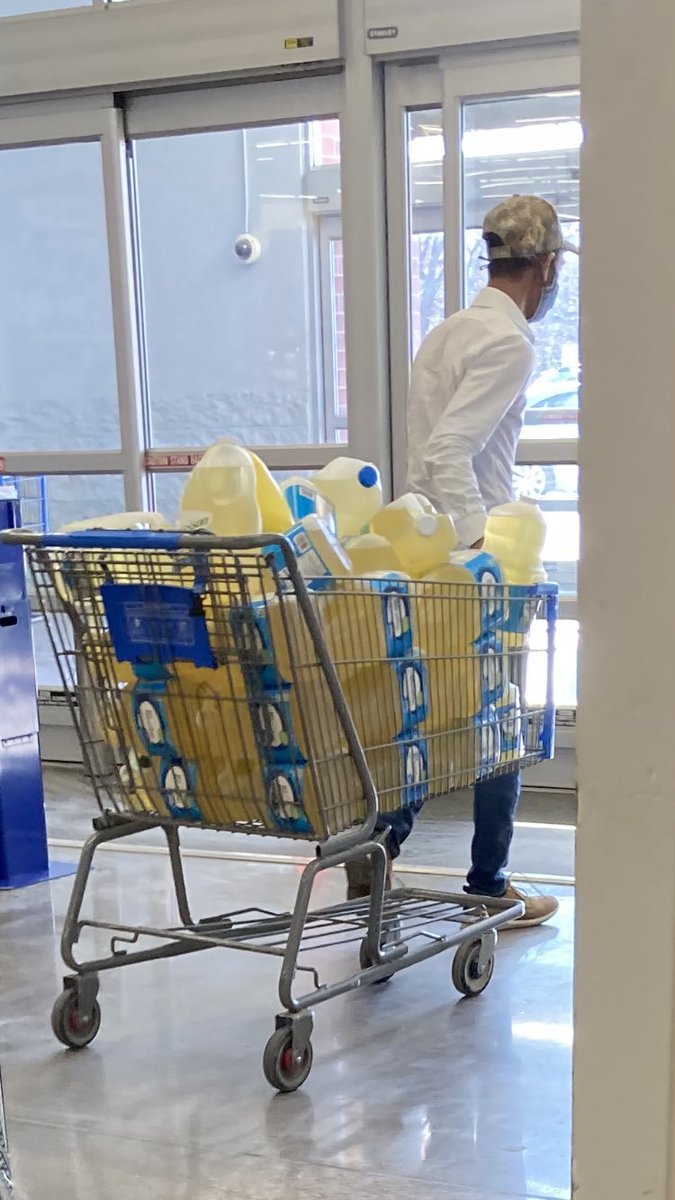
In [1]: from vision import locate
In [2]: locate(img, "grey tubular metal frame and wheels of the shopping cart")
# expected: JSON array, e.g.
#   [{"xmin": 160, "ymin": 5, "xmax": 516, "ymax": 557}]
[{"xmin": 4, "ymin": 532, "xmax": 557, "ymax": 1092}]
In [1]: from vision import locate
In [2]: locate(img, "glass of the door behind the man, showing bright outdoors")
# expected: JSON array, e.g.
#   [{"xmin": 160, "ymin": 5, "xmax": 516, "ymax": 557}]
[{"xmin": 461, "ymin": 91, "xmax": 581, "ymax": 598}]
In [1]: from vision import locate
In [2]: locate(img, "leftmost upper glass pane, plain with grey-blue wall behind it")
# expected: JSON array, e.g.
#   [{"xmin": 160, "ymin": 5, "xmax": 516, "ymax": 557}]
[{"xmin": 0, "ymin": 142, "xmax": 120, "ymax": 454}]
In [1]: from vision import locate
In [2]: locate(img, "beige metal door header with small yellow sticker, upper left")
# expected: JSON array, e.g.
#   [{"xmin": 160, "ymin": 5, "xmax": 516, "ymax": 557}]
[{"xmin": 0, "ymin": 0, "xmax": 340, "ymax": 97}]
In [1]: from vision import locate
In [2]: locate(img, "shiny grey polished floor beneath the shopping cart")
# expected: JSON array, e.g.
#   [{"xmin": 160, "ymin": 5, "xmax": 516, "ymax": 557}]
[{"xmin": 0, "ymin": 853, "xmax": 573, "ymax": 1200}]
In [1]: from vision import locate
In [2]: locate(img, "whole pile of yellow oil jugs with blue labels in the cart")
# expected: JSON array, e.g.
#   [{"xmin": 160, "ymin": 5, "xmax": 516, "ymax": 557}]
[{"xmin": 64, "ymin": 439, "xmax": 545, "ymax": 838}]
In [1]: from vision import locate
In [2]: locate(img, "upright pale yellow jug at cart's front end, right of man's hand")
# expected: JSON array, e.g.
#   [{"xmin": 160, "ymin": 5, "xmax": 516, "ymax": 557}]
[{"xmin": 483, "ymin": 499, "xmax": 546, "ymax": 586}]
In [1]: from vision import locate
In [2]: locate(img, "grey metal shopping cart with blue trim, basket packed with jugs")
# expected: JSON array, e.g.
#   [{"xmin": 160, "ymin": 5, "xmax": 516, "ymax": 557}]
[{"xmin": 5, "ymin": 530, "xmax": 557, "ymax": 1091}]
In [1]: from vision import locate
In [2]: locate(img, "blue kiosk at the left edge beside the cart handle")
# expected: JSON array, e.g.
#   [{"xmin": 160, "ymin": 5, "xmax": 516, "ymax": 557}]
[{"xmin": 0, "ymin": 487, "xmax": 73, "ymax": 890}]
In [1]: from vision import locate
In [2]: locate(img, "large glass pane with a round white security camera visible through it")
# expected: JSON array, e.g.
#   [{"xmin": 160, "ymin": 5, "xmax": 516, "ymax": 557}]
[{"xmin": 133, "ymin": 120, "xmax": 347, "ymax": 446}]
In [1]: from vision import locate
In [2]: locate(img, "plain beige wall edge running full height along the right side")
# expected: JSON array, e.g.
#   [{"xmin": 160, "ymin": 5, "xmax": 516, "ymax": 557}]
[{"xmin": 574, "ymin": 0, "xmax": 675, "ymax": 1200}]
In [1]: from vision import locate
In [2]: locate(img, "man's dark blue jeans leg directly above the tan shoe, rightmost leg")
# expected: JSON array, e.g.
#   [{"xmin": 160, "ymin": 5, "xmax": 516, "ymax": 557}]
[{"xmin": 466, "ymin": 770, "xmax": 520, "ymax": 896}]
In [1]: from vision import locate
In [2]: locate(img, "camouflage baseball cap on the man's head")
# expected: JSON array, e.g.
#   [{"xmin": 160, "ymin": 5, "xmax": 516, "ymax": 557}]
[{"xmin": 483, "ymin": 196, "xmax": 579, "ymax": 262}]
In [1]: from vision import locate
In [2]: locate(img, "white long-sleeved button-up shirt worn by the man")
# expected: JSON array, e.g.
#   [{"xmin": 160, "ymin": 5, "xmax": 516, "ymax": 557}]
[{"xmin": 408, "ymin": 287, "xmax": 534, "ymax": 546}]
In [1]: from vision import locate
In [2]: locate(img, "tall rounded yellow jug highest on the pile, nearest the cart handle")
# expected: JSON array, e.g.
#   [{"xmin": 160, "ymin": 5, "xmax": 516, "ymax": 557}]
[{"xmin": 180, "ymin": 438, "xmax": 263, "ymax": 538}]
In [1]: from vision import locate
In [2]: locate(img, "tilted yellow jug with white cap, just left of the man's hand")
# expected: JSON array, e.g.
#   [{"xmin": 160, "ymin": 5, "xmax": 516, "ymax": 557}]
[{"xmin": 370, "ymin": 492, "xmax": 458, "ymax": 578}]
